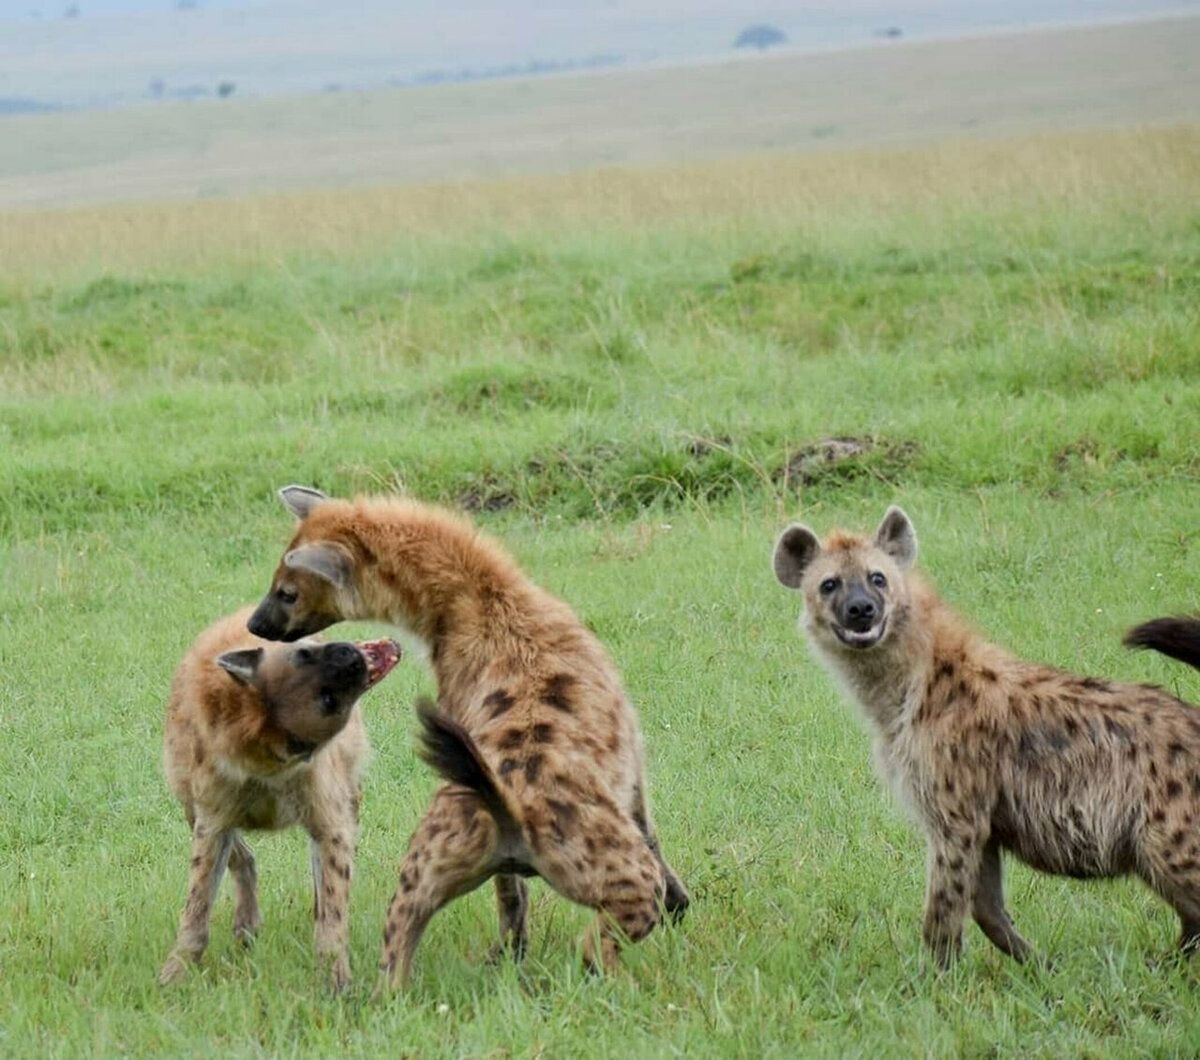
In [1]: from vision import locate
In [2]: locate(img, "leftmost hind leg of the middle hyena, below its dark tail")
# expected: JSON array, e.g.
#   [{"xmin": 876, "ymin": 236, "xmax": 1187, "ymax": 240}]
[{"xmin": 377, "ymin": 785, "xmax": 500, "ymax": 993}]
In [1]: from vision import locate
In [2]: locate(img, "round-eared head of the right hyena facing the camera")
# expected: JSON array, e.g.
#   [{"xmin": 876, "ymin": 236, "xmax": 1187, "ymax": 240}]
[{"xmin": 774, "ymin": 508, "xmax": 917, "ymax": 652}]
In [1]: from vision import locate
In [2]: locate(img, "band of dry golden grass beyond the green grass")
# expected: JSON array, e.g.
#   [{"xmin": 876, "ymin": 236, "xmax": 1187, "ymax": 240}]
[{"xmin": 7, "ymin": 125, "xmax": 1200, "ymax": 282}]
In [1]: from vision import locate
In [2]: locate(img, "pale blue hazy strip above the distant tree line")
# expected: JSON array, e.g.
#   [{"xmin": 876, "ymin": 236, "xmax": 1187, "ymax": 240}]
[{"xmin": 0, "ymin": 0, "xmax": 1200, "ymax": 104}]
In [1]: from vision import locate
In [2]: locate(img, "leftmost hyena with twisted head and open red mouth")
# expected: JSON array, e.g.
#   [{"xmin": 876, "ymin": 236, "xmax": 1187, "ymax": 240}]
[{"xmin": 158, "ymin": 607, "xmax": 400, "ymax": 988}]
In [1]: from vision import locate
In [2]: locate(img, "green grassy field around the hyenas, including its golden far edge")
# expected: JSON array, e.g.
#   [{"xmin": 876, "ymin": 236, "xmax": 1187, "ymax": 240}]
[{"xmin": 0, "ymin": 127, "xmax": 1200, "ymax": 1056}]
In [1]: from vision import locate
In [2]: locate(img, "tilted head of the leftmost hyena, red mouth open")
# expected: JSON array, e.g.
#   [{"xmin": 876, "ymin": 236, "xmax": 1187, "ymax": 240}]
[{"xmin": 216, "ymin": 640, "xmax": 401, "ymax": 759}]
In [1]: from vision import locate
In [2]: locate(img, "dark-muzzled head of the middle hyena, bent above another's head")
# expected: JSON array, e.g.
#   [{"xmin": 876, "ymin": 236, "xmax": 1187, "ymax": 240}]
[{"xmin": 247, "ymin": 486, "xmax": 355, "ymax": 641}]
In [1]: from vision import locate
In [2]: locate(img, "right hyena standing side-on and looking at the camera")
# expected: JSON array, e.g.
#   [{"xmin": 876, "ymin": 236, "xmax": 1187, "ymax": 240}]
[{"xmin": 774, "ymin": 508, "xmax": 1200, "ymax": 966}]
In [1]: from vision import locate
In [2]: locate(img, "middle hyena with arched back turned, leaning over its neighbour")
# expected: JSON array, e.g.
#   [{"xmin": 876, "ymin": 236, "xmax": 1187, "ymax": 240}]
[{"xmin": 250, "ymin": 486, "xmax": 688, "ymax": 987}]
